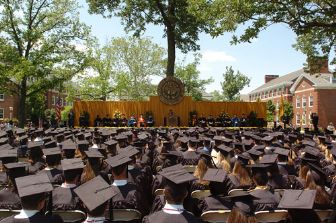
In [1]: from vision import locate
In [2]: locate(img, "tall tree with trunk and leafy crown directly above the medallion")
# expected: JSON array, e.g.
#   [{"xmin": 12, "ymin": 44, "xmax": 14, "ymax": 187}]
[{"xmin": 87, "ymin": 0, "xmax": 205, "ymax": 75}]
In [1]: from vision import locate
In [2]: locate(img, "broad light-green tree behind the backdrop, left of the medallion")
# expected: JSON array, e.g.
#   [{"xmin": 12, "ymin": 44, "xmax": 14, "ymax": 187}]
[{"xmin": 69, "ymin": 37, "xmax": 165, "ymax": 100}]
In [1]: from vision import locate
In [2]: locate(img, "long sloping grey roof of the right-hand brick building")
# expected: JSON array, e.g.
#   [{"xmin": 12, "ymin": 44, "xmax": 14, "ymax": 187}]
[{"xmin": 250, "ymin": 69, "xmax": 305, "ymax": 94}]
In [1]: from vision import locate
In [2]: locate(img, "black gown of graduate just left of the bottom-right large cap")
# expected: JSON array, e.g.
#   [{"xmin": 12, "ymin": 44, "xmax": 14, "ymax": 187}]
[{"xmin": 250, "ymin": 189, "xmax": 280, "ymax": 212}]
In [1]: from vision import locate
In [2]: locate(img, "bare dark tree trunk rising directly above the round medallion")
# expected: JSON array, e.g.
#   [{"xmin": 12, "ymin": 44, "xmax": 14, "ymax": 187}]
[{"xmin": 166, "ymin": 26, "xmax": 176, "ymax": 77}]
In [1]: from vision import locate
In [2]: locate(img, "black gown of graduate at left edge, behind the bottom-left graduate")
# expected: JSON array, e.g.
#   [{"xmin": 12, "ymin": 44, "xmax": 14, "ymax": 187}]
[{"xmin": 0, "ymin": 188, "xmax": 21, "ymax": 210}]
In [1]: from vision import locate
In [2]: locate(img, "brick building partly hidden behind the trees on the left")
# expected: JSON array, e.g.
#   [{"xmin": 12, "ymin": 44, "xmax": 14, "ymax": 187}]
[{"xmin": 0, "ymin": 90, "xmax": 72, "ymax": 120}]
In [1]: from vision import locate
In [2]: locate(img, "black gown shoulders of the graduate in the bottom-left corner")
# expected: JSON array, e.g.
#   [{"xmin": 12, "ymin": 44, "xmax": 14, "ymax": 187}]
[{"xmin": 0, "ymin": 212, "xmax": 63, "ymax": 223}]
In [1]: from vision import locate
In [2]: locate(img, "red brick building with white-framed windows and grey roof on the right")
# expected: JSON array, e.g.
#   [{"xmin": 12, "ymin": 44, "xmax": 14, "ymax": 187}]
[{"xmin": 249, "ymin": 61, "xmax": 336, "ymax": 127}]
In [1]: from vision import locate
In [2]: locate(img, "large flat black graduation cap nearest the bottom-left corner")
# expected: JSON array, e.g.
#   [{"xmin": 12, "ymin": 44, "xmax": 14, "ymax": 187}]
[{"xmin": 15, "ymin": 173, "xmax": 53, "ymax": 197}]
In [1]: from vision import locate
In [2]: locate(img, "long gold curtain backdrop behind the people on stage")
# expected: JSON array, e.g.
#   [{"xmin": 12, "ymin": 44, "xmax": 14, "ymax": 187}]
[{"xmin": 74, "ymin": 96, "xmax": 266, "ymax": 126}]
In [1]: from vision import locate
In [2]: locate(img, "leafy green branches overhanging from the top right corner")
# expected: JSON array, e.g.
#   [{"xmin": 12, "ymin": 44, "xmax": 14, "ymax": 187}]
[{"xmin": 189, "ymin": 0, "xmax": 336, "ymax": 72}]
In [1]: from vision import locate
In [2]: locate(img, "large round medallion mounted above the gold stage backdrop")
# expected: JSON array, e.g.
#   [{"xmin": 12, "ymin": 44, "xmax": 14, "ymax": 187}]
[{"xmin": 158, "ymin": 76, "xmax": 184, "ymax": 105}]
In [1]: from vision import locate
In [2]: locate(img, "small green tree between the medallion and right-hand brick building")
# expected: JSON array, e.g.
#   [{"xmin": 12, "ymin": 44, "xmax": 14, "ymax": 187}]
[{"xmin": 221, "ymin": 67, "xmax": 250, "ymax": 101}]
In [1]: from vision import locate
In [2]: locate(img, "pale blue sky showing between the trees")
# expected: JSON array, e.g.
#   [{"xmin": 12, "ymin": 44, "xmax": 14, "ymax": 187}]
[{"xmin": 79, "ymin": 0, "xmax": 306, "ymax": 94}]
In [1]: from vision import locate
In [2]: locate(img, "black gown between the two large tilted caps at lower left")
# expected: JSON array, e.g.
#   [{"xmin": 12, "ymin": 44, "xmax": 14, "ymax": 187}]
[{"xmin": 52, "ymin": 187, "xmax": 82, "ymax": 211}]
